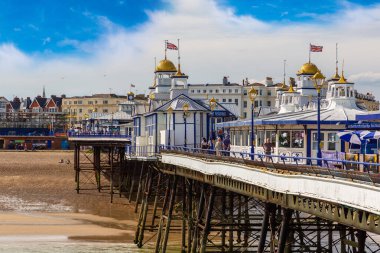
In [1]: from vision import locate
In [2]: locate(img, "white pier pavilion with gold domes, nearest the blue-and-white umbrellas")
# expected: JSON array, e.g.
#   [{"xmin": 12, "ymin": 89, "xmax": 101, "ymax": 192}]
[{"xmin": 217, "ymin": 61, "xmax": 368, "ymax": 160}]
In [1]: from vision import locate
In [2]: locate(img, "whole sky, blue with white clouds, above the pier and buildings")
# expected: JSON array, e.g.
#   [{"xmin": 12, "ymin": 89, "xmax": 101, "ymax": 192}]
[{"xmin": 0, "ymin": 0, "xmax": 380, "ymax": 98}]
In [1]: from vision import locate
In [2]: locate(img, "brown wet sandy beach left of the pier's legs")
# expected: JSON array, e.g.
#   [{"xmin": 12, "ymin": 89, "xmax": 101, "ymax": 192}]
[{"xmin": 0, "ymin": 151, "xmax": 137, "ymax": 243}]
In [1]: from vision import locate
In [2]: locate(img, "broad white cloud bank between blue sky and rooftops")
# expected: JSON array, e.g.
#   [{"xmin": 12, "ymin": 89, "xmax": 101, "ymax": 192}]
[{"xmin": 0, "ymin": 0, "xmax": 380, "ymax": 101}]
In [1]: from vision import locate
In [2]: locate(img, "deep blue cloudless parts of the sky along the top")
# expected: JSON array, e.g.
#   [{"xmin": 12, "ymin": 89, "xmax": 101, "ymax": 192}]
[{"xmin": 0, "ymin": 0, "xmax": 377, "ymax": 53}]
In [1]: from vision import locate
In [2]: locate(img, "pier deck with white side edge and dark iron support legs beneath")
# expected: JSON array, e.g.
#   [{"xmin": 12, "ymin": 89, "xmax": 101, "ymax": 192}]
[{"xmin": 70, "ymin": 137, "xmax": 380, "ymax": 253}]
